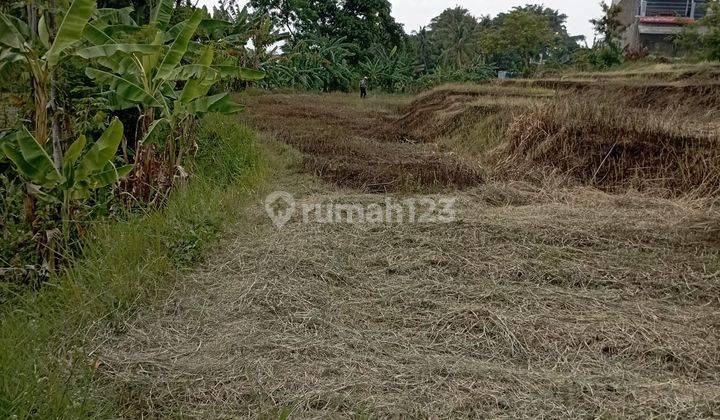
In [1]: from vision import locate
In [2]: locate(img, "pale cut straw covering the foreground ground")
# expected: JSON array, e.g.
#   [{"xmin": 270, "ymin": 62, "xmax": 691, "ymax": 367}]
[{"xmin": 98, "ymin": 94, "xmax": 720, "ymax": 418}]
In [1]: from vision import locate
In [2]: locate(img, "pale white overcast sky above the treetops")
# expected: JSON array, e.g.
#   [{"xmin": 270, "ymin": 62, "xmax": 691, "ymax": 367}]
[{"xmin": 199, "ymin": 0, "xmax": 601, "ymax": 44}]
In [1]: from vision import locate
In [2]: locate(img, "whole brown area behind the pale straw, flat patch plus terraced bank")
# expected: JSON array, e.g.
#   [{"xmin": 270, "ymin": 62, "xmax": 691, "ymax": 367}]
[{"xmin": 240, "ymin": 79, "xmax": 720, "ymax": 200}]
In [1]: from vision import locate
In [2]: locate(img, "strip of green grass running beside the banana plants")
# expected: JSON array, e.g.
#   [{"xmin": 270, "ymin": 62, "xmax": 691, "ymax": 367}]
[{"xmin": 0, "ymin": 115, "xmax": 265, "ymax": 418}]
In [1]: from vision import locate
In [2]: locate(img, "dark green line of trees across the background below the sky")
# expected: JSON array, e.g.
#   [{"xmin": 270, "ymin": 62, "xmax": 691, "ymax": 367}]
[{"xmin": 214, "ymin": 0, "xmax": 582, "ymax": 92}]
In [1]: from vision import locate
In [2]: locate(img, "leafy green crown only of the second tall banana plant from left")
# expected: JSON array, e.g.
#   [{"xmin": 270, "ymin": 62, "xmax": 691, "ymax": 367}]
[{"xmin": 82, "ymin": 7, "xmax": 263, "ymax": 121}]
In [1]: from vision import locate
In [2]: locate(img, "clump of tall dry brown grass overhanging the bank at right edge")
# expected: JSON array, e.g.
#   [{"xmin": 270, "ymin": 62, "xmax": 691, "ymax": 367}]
[{"xmin": 494, "ymin": 100, "xmax": 720, "ymax": 196}]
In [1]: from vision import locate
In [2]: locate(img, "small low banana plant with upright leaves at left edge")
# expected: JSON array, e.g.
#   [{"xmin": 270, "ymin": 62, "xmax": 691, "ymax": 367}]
[{"xmin": 0, "ymin": 118, "xmax": 133, "ymax": 242}]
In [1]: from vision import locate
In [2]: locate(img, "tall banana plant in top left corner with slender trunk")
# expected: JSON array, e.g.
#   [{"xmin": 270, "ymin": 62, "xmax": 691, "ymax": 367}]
[{"xmin": 0, "ymin": 0, "xmax": 96, "ymax": 165}]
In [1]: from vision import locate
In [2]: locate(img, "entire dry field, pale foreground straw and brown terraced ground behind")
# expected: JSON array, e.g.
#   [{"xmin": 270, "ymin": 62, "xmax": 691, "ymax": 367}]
[{"xmin": 95, "ymin": 67, "xmax": 720, "ymax": 418}]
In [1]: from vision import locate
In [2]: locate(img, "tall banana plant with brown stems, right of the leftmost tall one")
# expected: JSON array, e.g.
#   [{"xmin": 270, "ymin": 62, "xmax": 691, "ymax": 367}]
[{"xmin": 76, "ymin": 0, "xmax": 264, "ymax": 193}]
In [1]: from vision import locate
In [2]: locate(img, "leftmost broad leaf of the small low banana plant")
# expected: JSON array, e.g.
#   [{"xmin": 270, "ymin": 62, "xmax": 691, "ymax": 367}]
[{"xmin": 0, "ymin": 127, "xmax": 61, "ymax": 188}]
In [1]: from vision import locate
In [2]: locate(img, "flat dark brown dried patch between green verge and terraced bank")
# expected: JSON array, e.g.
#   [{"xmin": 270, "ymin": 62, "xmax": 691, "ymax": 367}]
[{"xmin": 245, "ymin": 95, "xmax": 484, "ymax": 192}]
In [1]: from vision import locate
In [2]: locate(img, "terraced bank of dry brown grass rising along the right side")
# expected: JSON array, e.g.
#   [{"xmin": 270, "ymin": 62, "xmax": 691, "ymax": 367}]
[{"xmin": 394, "ymin": 81, "xmax": 720, "ymax": 196}]
